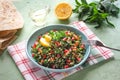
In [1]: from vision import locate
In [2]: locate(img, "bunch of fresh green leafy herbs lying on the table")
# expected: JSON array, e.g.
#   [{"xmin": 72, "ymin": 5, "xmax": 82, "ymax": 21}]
[{"xmin": 73, "ymin": 0, "xmax": 119, "ymax": 28}]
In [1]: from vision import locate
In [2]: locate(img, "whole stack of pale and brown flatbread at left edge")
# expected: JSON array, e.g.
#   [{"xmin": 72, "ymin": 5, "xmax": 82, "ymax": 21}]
[{"xmin": 0, "ymin": 0, "xmax": 24, "ymax": 54}]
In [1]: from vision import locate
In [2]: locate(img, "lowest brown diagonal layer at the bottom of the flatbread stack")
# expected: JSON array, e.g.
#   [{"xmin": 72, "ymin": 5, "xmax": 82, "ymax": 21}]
[{"xmin": 0, "ymin": 36, "xmax": 17, "ymax": 55}]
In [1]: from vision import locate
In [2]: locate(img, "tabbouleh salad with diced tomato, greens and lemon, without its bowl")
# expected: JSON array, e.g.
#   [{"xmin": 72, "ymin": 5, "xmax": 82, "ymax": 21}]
[{"xmin": 31, "ymin": 30, "xmax": 86, "ymax": 69}]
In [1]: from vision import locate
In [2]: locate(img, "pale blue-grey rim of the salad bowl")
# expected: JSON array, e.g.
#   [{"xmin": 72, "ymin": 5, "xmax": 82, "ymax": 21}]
[{"xmin": 25, "ymin": 24, "xmax": 91, "ymax": 72}]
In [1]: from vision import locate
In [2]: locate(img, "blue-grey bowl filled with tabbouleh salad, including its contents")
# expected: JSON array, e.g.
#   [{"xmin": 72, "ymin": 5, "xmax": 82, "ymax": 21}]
[{"xmin": 26, "ymin": 24, "xmax": 90, "ymax": 72}]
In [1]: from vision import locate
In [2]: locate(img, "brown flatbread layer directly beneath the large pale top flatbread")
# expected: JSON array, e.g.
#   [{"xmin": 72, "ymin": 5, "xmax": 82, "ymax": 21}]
[{"xmin": 0, "ymin": 30, "xmax": 17, "ymax": 38}]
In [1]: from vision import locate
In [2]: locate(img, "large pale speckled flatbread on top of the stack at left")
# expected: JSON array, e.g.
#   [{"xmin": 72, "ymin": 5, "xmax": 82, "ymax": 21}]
[{"xmin": 0, "ymin": 0, "xmax": 24, "ymax": 31}]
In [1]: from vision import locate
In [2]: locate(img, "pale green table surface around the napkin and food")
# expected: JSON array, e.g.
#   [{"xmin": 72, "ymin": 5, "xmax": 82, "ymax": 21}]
[{"xmin": 0, "ymin": 0, "xmax": 120, "ymax": 80}]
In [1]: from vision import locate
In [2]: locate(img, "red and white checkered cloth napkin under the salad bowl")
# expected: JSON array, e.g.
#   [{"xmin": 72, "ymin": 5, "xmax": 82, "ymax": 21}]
[{"xmin": 8, "ymin": 21, "xmax": 113, "ymax": 80}]
